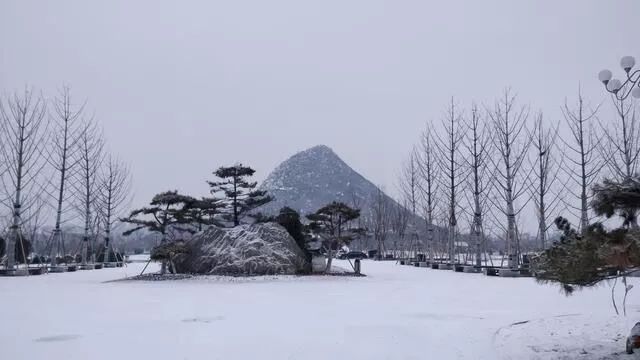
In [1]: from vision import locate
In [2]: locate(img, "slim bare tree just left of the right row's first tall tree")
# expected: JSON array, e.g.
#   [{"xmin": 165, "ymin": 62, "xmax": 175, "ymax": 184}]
[{"xmin": 418, "ymin": 125, "xmax": 439, "ymax": 260}]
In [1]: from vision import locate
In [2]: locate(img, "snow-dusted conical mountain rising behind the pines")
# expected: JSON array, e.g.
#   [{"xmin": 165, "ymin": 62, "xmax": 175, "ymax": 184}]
[{"xmin": 260, "ymin": 145, "xmax": 396, "ymax": 216}]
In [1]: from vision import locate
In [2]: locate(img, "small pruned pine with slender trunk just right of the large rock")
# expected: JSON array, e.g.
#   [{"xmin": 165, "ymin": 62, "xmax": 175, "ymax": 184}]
[{"xmin": 307, "ymin": 201, "xmax": 362, "ymax": 273}]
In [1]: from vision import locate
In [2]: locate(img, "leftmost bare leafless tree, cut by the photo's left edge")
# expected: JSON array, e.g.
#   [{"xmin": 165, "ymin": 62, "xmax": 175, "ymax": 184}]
[{"xmin": 0, "ymin": 90, "xmax": 48, "ymax": 269}]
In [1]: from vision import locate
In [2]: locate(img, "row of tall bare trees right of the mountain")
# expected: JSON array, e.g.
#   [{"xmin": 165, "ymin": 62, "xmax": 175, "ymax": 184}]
[{"xmin": 368, "ymin": 89, "xmax": 640, "ymax": 267}]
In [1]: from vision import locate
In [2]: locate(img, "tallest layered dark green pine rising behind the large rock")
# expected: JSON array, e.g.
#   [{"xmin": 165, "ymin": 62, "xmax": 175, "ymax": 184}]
[{"xmin": 208, "ymin": 164, "xmax": 273, "ymax": 226}]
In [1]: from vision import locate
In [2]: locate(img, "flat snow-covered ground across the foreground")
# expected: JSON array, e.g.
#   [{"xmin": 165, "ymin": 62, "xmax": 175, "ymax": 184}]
[{"xmin": 0, "ymin": 261, "xmax": 640, "ymax": 360}]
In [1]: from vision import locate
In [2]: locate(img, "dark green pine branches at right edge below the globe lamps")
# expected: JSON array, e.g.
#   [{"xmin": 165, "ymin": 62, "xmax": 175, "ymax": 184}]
[{"xmin": 532, "ymin": 177, "xmax": 640, "ymax": 293}]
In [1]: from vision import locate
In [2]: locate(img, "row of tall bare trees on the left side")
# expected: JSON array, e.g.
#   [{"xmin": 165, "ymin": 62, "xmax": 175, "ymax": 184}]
[{"xmin": 0, "ymin": 87, "xmax": 131, "ymax": 269}]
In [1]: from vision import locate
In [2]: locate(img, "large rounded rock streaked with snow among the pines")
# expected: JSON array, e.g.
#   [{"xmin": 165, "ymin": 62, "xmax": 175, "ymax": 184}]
[{"xmin": 174, "ymin": 223, "xmax": 309, "ymax": 275}]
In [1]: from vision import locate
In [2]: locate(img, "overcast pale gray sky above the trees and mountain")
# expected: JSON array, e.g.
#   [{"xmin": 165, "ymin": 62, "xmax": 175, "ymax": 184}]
[{"xmin": 0, "ymin": 0, "xmax": 640, "ymax": 231}]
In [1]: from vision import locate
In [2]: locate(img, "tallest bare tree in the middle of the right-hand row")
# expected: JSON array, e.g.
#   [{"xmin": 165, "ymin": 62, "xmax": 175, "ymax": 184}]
[{"xmin": 488, "ymin": 89, "xmax": 531, "ymax": 268}]
